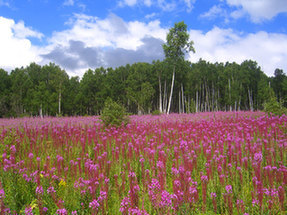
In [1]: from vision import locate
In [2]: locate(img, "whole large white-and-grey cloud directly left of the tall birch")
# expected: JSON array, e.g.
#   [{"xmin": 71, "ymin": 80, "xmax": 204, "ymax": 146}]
[{"xmin": 41, "ymin": 14, "xmax": 167, "ymax": 76}]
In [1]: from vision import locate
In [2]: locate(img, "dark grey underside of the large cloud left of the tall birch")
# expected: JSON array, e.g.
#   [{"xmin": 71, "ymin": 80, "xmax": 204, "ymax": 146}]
[{"xmin": 41, "ymin": 37, "xmax": 164, "ymax": 71}]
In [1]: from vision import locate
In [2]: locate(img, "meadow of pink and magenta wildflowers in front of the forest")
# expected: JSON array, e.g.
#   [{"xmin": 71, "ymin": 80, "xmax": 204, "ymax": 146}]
[{"xmin": 0, "ymin": 112, "xmax": 287, "ymax": 215}]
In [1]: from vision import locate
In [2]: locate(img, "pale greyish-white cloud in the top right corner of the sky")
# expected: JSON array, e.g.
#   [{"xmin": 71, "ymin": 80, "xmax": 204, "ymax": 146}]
[{"xmin": 226, "ymin": 0, "xmax": 287, "ymax": 23}]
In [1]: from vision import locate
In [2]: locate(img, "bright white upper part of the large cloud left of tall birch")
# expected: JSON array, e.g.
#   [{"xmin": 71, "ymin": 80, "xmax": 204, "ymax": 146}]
[{"xmin": 49, "ymin": 14, "xmax": 166, "ymax": 50}]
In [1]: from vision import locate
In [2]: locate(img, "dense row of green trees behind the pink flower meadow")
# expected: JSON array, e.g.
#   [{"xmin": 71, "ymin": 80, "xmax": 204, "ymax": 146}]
[{"xmin": 0, "ymin": 60, "xmax": 287, "ymax": 117}]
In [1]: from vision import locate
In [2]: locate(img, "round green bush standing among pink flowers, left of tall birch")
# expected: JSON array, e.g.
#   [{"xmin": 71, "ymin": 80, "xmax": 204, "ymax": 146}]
[{"xmin": 100, "ymin": 98, "xmax": 129, "ymax": 127}]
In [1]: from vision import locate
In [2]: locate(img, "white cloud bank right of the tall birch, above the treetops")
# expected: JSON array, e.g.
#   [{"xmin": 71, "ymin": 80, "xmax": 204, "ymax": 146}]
[{"xmin": 190, "ymin": 27, "xmax": 287, "ymax": 76}]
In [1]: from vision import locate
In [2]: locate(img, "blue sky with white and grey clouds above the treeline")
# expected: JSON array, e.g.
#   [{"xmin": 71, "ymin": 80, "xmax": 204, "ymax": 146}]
[{"xmin": 0, "ymin": 0, "xmax": 287, "ymax": 77}]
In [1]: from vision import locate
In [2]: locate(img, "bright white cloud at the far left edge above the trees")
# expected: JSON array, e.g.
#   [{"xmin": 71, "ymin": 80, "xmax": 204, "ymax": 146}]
[{"xmin": 0, "ymin": 16, "xmax": 43, "ymax": 70}]
